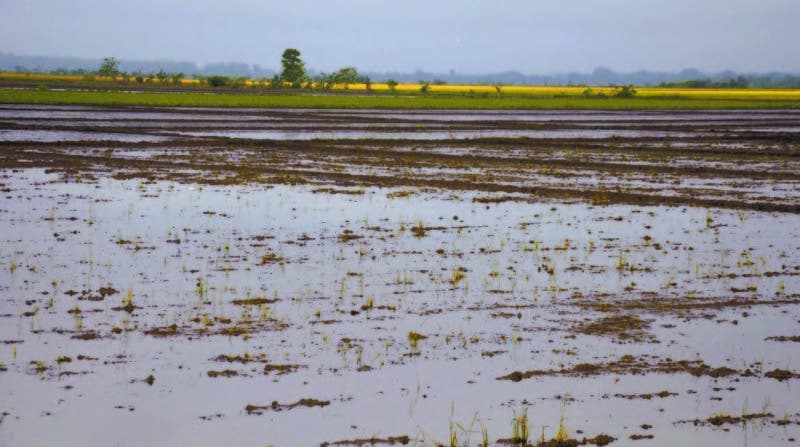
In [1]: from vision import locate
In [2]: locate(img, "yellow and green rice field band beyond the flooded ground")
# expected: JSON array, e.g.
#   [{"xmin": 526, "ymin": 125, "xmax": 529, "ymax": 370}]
[{"xmin": 0, "ymin": 73, "xmax": 800, "ymax": 109}]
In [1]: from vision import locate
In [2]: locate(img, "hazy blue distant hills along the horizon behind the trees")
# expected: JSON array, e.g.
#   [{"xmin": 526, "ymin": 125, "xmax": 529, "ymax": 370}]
[{"xmin": 0, "ymin": 52, "xmax": 800, "ymax": 87}]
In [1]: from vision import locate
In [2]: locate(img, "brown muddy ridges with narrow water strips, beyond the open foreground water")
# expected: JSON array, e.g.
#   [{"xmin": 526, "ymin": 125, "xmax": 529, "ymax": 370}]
[{"xmin": 0, "ymin": 105, "xmax": 800, "ymax": 213}]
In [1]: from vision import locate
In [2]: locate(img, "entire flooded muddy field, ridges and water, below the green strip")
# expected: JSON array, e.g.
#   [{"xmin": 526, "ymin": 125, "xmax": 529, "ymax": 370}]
[{"xmin": 0, "ymin": 105, "xmax": 800, "ymax": 446}]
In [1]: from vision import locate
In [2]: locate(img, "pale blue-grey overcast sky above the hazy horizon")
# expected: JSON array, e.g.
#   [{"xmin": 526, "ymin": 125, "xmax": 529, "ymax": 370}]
[{"xmin": 0, "ymin": 0, "xmax": 800, "ymax": 73}]
